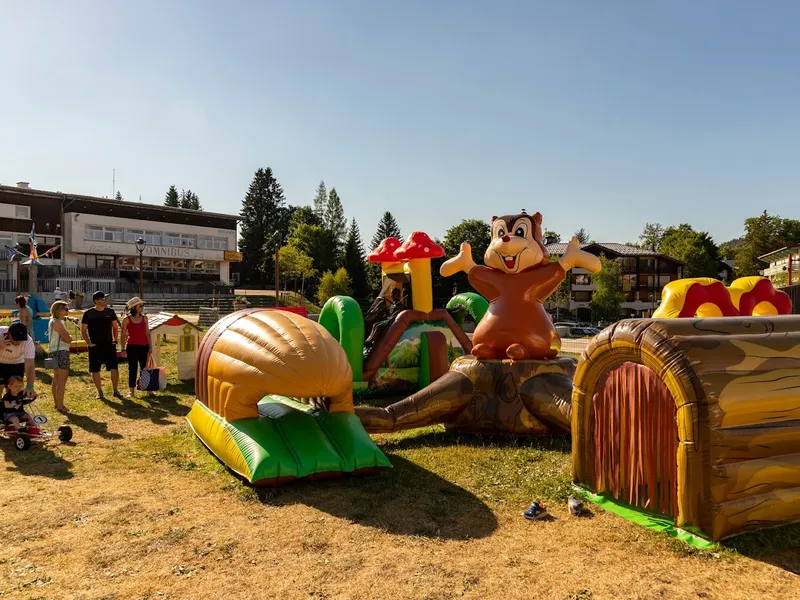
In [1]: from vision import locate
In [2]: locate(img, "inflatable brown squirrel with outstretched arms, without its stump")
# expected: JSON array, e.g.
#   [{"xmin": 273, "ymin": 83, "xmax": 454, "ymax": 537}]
[{"xmin": 440, "ymin": 210, "xmax": 600, "ymax": 360}]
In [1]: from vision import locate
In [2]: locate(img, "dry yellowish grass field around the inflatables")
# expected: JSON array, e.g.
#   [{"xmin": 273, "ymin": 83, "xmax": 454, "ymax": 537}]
[{"xmin": 0, "ymin": 345, "xmax": 800, "ymax": 600}]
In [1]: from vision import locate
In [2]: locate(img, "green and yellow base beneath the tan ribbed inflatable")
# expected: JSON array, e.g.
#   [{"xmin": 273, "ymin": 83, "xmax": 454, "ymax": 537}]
[{"xmin": 194, "ymin": 396, "xmax": 392, "ymax": 486}]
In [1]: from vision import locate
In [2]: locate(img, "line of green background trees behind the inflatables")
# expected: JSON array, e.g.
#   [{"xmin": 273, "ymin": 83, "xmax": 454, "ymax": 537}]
[{"xmin": 236, "ymin": 167, "xmax": 800, "ymax": 306}]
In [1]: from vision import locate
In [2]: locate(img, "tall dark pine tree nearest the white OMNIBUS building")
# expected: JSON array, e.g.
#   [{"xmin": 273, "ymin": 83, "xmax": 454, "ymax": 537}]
[{"xmin": 239, "ymin": 167, "xmax": 289, "ymax": 283}]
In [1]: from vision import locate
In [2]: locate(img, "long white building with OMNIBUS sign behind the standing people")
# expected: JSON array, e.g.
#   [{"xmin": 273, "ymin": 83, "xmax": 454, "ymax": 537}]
[{"xmin": 0, "ymin": 184, "xmax": 241, "ymax": 304}]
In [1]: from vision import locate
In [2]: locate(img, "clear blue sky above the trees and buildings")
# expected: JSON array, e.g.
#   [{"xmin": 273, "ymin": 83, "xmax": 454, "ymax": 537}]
[{"xmin": 0, "ymin": 0, "xmax": 800, "ymax": 245}]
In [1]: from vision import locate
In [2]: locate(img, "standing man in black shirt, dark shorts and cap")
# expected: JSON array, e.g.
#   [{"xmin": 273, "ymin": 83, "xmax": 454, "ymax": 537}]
[{"xmin": 81, "ymin": 291, "xmax": 122, "ymax": 400}]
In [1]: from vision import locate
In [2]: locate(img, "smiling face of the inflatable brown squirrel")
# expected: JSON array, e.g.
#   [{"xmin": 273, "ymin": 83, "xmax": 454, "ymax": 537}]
[{"xmin": 483, "ymin": 213, "xmax": 545, "ymax": 273}]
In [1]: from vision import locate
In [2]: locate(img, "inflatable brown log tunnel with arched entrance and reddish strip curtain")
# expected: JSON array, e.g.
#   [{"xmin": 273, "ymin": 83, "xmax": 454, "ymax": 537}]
[{"xmin": 572, "ymin": 316, "xmax": 800, "ymax": 540}]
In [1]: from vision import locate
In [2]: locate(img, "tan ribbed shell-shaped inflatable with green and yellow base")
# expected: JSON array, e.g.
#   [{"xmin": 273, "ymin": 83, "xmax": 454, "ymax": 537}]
[{"xmin": 187, "ymin": 309, "xmax": 391, "ymax": 485}]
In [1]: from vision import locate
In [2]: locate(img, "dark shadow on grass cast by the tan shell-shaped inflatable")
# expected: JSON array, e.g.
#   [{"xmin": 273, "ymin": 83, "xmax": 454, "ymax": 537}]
[{"xmin": 256, "ymin": 454, "xmax": 497, "ymax": 540}]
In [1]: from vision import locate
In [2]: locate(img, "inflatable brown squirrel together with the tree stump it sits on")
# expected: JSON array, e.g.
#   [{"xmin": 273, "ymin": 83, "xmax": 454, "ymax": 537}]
[{"xmin": 356, "ymin": 211, "xmax": 600, "ymax": 436}]
